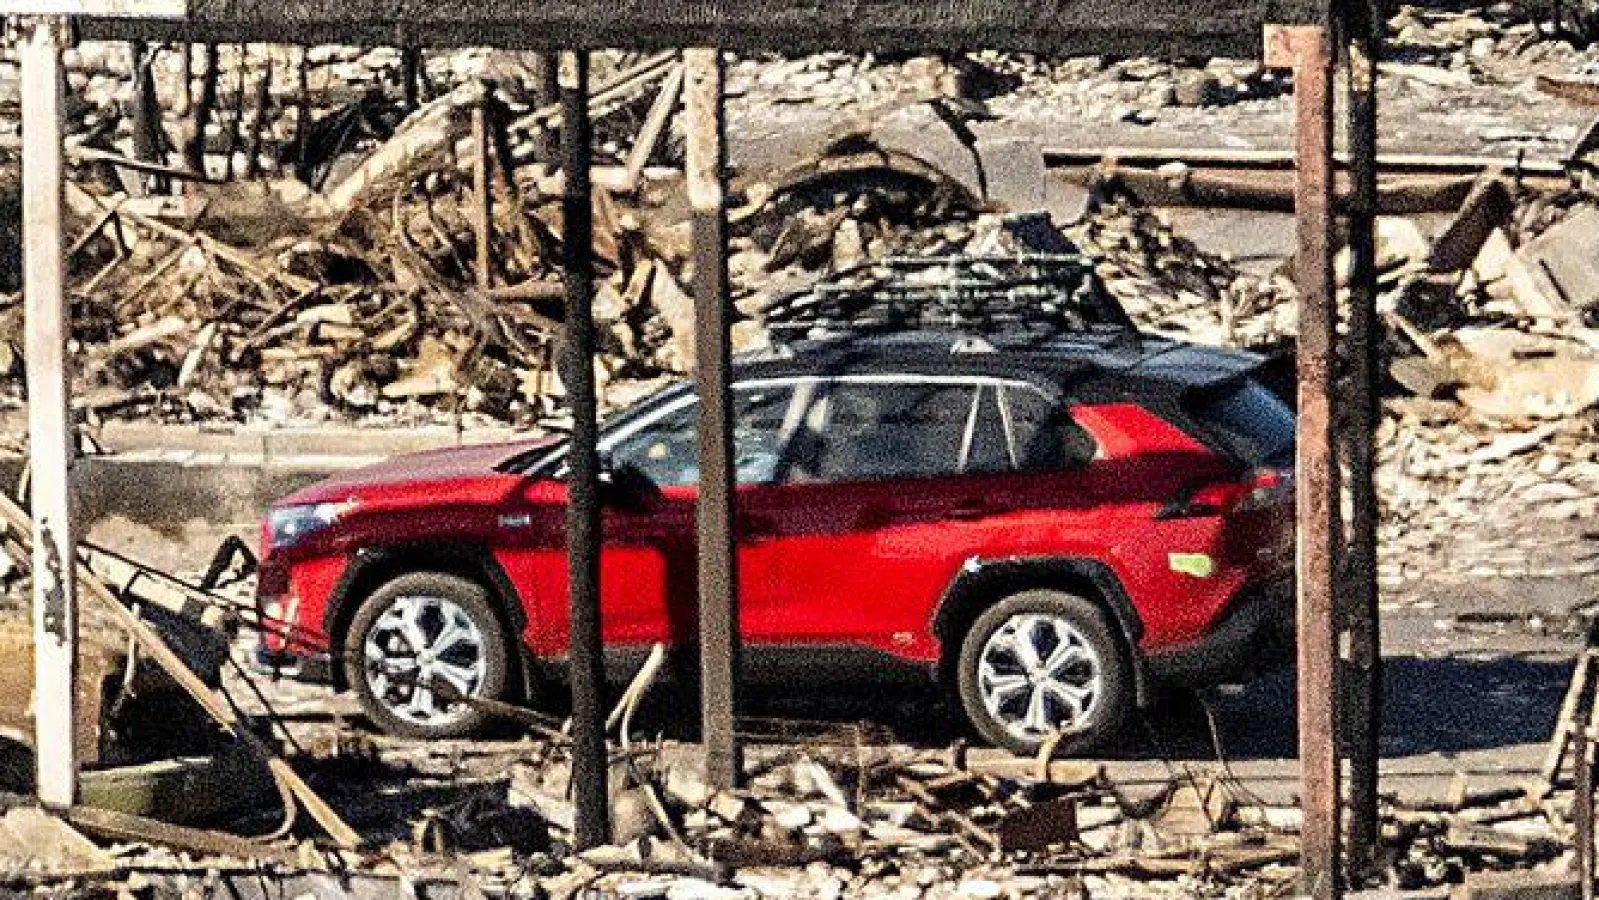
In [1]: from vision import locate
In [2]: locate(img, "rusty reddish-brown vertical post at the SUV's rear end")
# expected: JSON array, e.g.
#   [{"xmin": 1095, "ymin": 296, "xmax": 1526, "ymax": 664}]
[{"xmin": 1274, "ymin": 26, "xmax": 1342, "ymax": 898}]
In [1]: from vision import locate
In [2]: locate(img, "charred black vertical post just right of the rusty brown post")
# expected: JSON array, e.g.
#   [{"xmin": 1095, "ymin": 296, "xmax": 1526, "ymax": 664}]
[{"xmin": 1343, "ymin": 3, "xmax": 1383, "ymax": 878}]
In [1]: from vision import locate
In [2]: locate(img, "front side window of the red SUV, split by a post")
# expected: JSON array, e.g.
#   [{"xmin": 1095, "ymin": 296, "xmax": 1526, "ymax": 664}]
[{"xmin": 608, "ymin": 385, "xmax": 793, "ymax": 488}]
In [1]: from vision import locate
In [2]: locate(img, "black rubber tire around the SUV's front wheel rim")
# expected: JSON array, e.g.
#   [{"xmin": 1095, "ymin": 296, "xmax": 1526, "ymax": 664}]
[{"xmin": 342, "ymin": 572, "xmax": 512, "ymax": 739}]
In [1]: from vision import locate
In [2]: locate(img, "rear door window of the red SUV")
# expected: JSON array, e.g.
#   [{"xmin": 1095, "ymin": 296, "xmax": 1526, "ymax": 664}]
[{"xmin": 788, "ymin": 380, "xmax": 977, "ymax": 481}]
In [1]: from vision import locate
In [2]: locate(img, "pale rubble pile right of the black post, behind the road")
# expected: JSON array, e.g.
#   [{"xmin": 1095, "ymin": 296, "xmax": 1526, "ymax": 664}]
[{"xmin": 1355, "ymin": 177, "xmax": 1599, "ymax": 588}]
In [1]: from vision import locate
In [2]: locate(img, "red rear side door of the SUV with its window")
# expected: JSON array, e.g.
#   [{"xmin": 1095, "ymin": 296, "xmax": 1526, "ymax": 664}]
[{"xmin": 740, "ymin": 374, "xmax": 1009, "ymax": 659}]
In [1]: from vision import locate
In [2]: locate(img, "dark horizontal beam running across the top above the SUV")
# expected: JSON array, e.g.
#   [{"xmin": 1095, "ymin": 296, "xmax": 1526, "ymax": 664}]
[{"xmin": 77, "ymin": 0, "xmax": 1327, "ymax": 56}]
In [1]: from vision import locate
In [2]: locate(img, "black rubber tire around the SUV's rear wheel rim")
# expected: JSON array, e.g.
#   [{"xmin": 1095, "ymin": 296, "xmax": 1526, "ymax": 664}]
[{"xmin": 956, "ymin": 590, "xmax": 1135, "ymax": 756}]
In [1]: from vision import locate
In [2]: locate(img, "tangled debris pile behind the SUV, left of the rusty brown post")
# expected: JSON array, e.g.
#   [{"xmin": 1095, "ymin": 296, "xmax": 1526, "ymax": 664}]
[{"xmin": 0, "ymin": 76, "xmax": 1290, "ymax": 425}]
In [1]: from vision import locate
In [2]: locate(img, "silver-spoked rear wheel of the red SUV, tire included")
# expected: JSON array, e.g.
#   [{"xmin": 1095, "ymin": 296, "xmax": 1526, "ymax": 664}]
[{"xmin": 956, "ymin": 590, "xmax": 1135, "ymax": 756}]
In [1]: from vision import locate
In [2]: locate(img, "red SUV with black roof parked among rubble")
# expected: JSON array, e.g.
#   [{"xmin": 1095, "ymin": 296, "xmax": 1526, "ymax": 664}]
[{"xmin": 259, "ymin": 326, "xmax": 1294, "ymax": 751}]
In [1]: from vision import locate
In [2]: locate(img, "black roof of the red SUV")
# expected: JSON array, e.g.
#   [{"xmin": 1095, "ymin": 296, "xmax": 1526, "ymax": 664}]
[{"xmin": 732, "ymin": 326, "xmax": 1263, "ymax": 395}]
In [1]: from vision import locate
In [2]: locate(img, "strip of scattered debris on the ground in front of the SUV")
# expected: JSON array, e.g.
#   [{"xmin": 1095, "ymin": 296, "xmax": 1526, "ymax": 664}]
[{"xmin": 0, "ymin": 626, "xmax": 1573, "ymax": 900}]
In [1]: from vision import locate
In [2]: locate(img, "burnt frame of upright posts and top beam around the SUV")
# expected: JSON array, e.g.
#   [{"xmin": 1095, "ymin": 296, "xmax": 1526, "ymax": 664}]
[{"xmin": 0, "ymin": 0, "xmax": 1382, "ymax": 897}]
